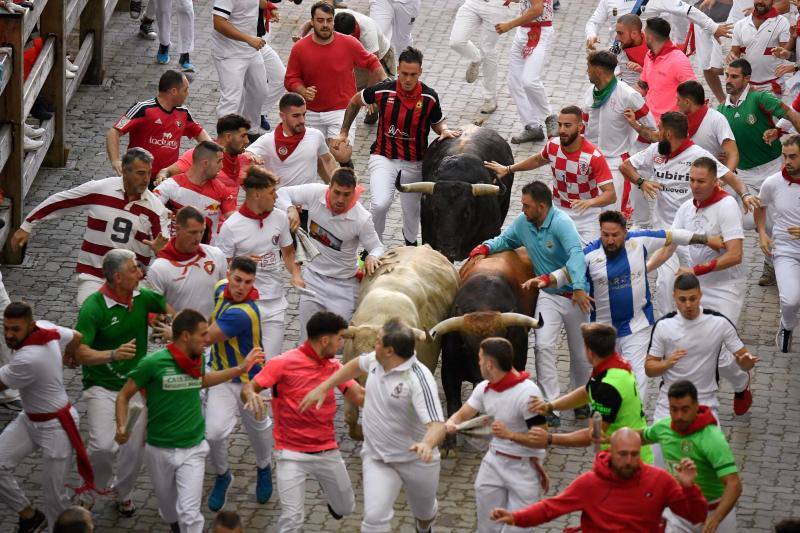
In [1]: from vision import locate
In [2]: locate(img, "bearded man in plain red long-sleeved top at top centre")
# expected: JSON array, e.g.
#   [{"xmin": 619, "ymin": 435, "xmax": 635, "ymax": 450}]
[{"xmin": 284, "ymin": 2, "xmax": 386, "ymax": 163}]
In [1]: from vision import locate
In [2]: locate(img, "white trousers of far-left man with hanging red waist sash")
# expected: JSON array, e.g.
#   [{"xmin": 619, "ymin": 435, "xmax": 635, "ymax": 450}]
[{"xmin": 0, "ymin": 407, "xmax": 78, "ymax": 531}]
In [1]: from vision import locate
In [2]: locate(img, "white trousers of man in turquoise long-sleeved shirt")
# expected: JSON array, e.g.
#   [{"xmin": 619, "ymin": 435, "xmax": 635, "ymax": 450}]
[{"xmin": 533, "ymin": 291, "xmax": 592, "ymax": 400}]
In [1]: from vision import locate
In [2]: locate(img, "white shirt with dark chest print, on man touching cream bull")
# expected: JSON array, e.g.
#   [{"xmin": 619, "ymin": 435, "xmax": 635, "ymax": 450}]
[{"xmin": 276, "ymin": 183, "xmax": 384, "ymax": 279}]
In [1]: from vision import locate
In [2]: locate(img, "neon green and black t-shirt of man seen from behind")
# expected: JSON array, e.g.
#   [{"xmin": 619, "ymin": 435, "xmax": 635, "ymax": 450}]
[{"xmin": 586, "ymin": 368, "xmax": 653, "ymax": 464}]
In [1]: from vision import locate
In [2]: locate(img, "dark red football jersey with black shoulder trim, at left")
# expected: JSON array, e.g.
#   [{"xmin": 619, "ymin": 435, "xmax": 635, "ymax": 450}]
[{"xmin": 114, "ymin": 98, "xmax": 203, "ymax": 176}]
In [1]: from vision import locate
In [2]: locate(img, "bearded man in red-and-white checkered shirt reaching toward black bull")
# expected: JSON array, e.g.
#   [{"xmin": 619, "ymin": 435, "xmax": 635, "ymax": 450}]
[{"xmin": 485, "ymin": 106, "xmax": 617, "ymax": 244}]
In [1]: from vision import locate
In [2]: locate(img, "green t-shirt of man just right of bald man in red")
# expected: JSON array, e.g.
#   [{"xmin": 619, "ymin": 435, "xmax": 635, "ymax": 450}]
[{"xmin": 644, "ymin": 417, "xmax": 738, "ymax": 502}]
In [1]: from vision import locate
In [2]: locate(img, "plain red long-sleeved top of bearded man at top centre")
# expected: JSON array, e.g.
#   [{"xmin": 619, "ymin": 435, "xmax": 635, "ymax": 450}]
[{"xmin": 284, "ymin": 32, "xmax": 380, "ymax": 112}]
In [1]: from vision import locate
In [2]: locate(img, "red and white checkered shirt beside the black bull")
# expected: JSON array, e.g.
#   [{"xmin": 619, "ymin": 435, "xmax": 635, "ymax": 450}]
[{"xmin": 541, "ymin": 137, "xmax": 612, "ymax": 209}]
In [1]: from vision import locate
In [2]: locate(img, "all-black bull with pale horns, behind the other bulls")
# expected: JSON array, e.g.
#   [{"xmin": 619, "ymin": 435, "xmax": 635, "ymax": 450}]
[{"xmin": 395, "ymin": 126, "xmax": 514, "ymax": 261}]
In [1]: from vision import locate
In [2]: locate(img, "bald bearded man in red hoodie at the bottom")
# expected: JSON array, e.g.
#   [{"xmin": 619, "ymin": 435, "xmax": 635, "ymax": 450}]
[{"xmin": 492, "ymin": 428, "xmax": 707, "ymax": 533}]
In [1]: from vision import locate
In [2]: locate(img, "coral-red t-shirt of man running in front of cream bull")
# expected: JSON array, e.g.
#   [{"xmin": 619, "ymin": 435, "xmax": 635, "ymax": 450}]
[{"xmin": 253, "ymin": 343, "xmax": 355, "ymax": 453}]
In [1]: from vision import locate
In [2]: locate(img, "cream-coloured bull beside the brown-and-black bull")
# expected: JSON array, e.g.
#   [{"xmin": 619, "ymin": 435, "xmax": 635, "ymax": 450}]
[{"xmin": 344, "ymin": 246, "xmax": 458, "ymax": 440}]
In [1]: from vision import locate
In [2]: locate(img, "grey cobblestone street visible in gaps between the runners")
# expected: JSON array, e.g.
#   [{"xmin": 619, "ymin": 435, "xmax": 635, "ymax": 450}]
[{"xmin": 0, "ymin": 0, "xmax": 800, "ymax": 533}]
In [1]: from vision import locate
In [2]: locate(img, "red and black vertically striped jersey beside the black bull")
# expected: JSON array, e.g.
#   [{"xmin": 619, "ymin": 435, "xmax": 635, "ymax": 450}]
[{"xmin": 361, "ymin": 80, "xmax": 444, "ymax": 161}]
